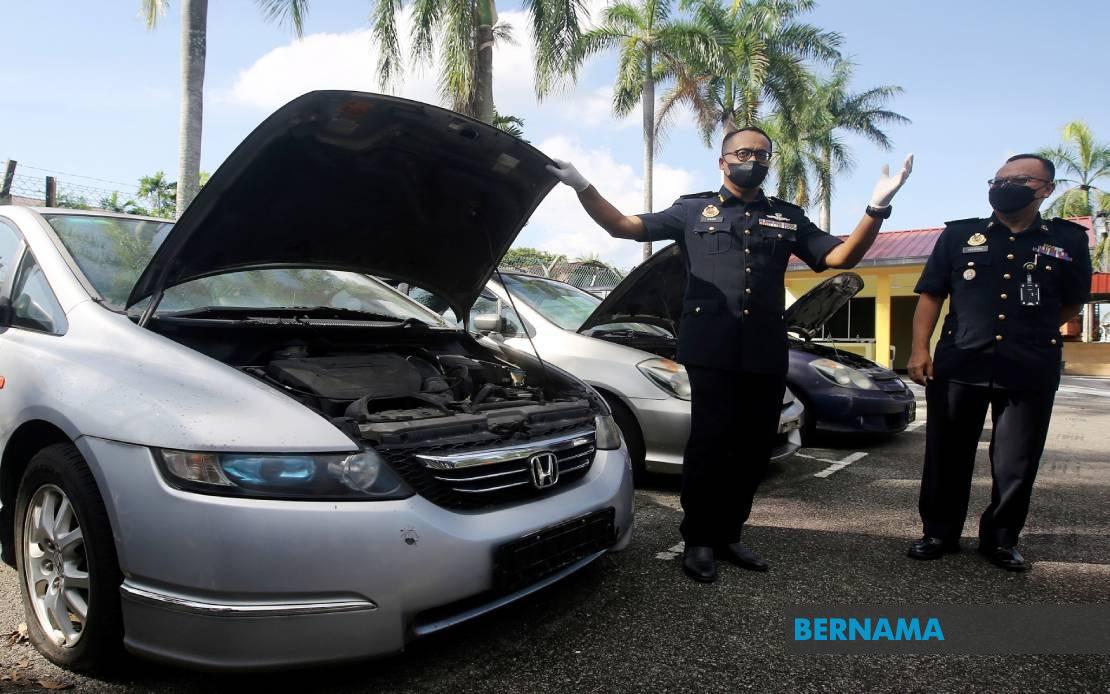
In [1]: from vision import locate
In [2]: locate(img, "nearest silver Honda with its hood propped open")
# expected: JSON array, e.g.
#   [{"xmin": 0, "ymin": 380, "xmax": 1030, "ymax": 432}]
[{"xmin": 0, "ymin": 92, "xmax": 633, "ymax": 670}]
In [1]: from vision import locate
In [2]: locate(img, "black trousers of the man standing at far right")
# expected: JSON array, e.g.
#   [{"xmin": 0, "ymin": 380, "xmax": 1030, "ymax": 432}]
[{"xmin": 918, "ymin": 381, "xmax": 1056, "ymax": 546}]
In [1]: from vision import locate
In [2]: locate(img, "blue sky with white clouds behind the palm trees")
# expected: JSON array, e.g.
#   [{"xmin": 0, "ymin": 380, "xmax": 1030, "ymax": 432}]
[{"xmin": 0, "ymin": 0, "xmax": 1110, "ymax": 268}]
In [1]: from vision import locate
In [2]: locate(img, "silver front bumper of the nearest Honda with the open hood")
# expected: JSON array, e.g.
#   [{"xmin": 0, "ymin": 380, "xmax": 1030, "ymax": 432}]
[{"xmin": 78, "ymin": 437, "xmax": 633, "ymax": 670}]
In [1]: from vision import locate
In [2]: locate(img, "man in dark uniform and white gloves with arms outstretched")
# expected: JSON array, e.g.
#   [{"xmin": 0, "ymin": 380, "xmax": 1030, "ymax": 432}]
[{"xmin": 548, "ymin": 128, "xmax": 912, "ymax": 582}]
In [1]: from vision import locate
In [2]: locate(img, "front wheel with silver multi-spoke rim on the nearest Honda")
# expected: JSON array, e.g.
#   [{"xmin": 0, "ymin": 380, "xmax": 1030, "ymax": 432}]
[{"xmin": 14, "ymin": 443, "xmax": 123, "ymax": 672}]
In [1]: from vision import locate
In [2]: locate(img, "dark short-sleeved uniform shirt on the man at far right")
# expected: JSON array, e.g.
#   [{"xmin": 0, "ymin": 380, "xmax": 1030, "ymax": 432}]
[{"xmin": 914, "ymin": 215, "xmax": 1091, "ymax": 389}]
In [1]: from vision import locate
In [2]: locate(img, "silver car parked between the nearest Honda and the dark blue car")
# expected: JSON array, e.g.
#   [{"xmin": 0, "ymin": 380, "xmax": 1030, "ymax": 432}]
[{"xmin": 410, "ymin": 270, "xmax": 803, "ymax": 473}]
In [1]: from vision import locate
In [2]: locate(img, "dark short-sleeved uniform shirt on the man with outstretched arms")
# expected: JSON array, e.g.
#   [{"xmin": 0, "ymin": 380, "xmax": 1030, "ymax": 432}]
[{"xmin": 639, "ymin": 188, "xmax": 840, "ymax": 373}]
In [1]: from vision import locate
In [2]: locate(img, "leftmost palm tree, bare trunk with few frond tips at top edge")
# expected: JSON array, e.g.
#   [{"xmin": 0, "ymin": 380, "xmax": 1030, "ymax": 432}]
[{"xmin": 140, "ymin": 0, "xmax": 309, "ymax": 217}]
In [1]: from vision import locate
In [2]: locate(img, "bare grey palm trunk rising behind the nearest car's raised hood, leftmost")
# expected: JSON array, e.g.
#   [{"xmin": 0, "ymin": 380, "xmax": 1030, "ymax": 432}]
[{"xmin": 178, "ymin": 0, "xmax": 208, "ymax": 217}]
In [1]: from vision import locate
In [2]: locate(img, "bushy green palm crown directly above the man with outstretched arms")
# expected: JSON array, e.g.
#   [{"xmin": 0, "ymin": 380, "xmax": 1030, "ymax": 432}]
[{"xmin": 657, "ymin": 0, "xmax": 842, "ymax": 147}]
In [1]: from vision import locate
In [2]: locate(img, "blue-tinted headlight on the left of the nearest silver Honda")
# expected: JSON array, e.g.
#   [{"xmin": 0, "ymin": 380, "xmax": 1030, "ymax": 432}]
[{"xmin": 155, "ymin": 450, "xmax": 413, "ymax": 501}]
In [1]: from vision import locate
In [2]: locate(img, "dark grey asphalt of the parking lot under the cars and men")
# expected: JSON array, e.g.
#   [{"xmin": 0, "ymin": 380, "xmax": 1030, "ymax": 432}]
[{"xmin": 0, "ymin": 379, "xmax": 1110, "ymax": 693}]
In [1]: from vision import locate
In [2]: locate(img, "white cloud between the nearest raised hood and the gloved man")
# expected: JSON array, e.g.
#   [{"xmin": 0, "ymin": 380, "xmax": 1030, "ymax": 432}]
[{"xmin": 519, "ymin": 137, "xmax": 695, "ymax": 269}]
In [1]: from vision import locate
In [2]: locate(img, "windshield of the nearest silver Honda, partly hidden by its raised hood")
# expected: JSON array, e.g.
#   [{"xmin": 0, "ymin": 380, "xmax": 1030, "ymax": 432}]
[{"xmin": 47, "ymin": 214, "xmax": 453, "ymax": 328}]
